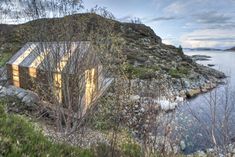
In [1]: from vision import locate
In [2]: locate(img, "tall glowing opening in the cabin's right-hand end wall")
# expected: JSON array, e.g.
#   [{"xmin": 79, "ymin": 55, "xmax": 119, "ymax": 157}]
[{"xmin": 85, "ymin": 68, "xmax": 96, "ymax": 109}]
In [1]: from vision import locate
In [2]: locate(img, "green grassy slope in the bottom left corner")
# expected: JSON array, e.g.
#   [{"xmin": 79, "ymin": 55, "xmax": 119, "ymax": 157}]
[{"xmin": 0, "ymin": 101, "xmax": 94, "ymax": 157}]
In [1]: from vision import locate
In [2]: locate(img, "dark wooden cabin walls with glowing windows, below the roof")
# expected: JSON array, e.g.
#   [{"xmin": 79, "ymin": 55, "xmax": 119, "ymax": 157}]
[{"xmin": 7, "ymin": 64, "xmax": 103, "ymax": 111}]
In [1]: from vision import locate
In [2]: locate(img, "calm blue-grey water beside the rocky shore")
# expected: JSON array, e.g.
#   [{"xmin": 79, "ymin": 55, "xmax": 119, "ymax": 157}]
[{"xmin": 175, "ymin": 51, "xmax": 235, "ymax": 154}]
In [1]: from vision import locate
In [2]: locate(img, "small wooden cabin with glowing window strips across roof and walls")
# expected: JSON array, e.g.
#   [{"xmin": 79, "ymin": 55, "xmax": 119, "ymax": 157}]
[{"xmin": 7, "ymin": 41, "xmax": 111, "ymax": 112}]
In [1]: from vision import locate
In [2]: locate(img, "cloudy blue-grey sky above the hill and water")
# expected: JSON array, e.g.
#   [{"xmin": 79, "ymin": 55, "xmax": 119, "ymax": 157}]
[{"xmin": 84, "ymin": 0, "xmax": 235, "ymax": 48}]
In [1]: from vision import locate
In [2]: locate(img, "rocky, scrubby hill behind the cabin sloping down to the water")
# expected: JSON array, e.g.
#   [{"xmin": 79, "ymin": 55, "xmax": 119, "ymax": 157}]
[{"xmin": 0, "ymin": 13, "xmax": 225, "ymax": 98}]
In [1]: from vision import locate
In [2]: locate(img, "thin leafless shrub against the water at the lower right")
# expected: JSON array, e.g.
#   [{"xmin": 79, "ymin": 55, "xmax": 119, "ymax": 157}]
[{"xmin": 185, "ymin": 81, "xmax": 235, "ymax": 155}]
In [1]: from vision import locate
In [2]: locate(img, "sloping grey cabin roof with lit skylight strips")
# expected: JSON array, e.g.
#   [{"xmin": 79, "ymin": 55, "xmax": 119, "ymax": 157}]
[{"xmin": 7, "ymin": 41, "xmax": 99, "ymax": 73}]
